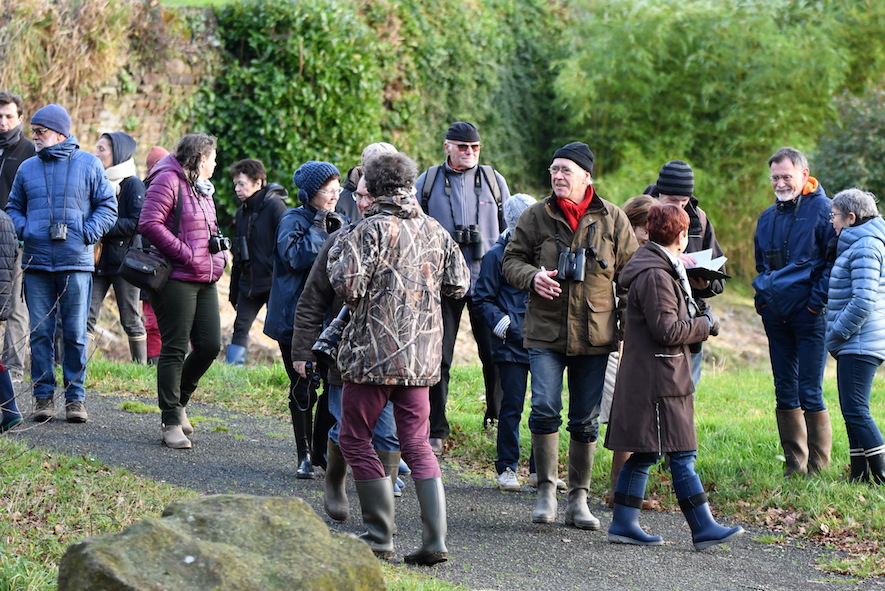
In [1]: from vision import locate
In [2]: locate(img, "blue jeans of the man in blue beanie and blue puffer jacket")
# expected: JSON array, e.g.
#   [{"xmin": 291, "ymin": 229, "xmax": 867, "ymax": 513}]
[{"xmin": 24, "ymin": 271, "xmax": 92, "ymax": 402}]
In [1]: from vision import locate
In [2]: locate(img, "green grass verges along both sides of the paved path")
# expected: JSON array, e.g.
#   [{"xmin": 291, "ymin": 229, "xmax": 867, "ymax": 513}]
[{"xmin": 0, "ymin": 359, "xmax": 885, "ymax": 591}]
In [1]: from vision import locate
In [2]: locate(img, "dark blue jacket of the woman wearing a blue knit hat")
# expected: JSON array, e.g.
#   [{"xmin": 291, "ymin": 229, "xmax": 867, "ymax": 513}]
[{"xmin": 264, "ymin": 205, "xmax": 329, "ymax": 345}]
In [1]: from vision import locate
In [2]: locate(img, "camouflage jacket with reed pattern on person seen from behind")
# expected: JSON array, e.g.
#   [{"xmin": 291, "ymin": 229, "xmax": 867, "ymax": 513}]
[{"xmin": 327, "ymin": 197, "xmax": 470, "ymax": 386}]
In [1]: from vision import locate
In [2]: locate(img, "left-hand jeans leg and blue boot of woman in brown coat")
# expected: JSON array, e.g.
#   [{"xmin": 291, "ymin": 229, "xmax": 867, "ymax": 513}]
[{"xmin": 608, "ymin": 454, "xmax": 664, "ymax": 546}]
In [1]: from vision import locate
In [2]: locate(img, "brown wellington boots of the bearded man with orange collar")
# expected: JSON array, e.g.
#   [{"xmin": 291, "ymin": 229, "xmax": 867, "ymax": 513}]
[{"xmin": 775, "ymin": 408, "xmax": 833, "ymax": 476}]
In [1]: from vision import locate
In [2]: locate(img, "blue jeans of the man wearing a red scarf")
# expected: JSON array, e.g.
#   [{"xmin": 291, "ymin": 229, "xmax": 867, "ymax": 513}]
[{"xmin": 529, "ymin": 349, "xmax": 608, "ymax": 443}]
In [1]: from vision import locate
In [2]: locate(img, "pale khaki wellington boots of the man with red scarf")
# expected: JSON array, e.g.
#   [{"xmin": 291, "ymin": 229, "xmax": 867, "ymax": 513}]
[{"xmin": 532, "ymin": 432, "xmax": 599, "ymax": 531}]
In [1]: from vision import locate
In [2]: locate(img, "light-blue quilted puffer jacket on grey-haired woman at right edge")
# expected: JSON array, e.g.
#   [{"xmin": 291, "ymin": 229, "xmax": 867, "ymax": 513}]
[{"xmin": 827, "ymin": 217, "xmax": 885, "ymax": 359}]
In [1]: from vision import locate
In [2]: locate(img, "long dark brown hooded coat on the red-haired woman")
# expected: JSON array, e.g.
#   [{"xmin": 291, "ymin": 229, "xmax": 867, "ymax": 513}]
[{"xmin": 605, "ymin": 242, "xmax": 710, "ymax": 453}]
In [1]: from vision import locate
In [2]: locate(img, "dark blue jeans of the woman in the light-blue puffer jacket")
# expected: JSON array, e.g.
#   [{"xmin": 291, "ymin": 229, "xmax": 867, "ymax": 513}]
[{"xmin": 836, "ymin": 355, "xmax": 885, "ymax": 450}]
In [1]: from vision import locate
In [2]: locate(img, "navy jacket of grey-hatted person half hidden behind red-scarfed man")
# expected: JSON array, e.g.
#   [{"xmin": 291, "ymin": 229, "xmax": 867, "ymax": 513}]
[{"xmin": 473, "ymin": 231, "xmax": 529, "ymax": 363}]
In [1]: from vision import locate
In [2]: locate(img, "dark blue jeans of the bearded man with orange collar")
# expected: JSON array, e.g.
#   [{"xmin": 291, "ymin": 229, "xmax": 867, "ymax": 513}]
[{"xmin": 762, "ymin": 306, "xmax": 827, "ymax": 412}]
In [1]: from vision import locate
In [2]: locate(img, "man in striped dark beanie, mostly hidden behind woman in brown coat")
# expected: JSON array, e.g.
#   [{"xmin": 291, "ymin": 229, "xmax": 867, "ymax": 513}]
[{"xmin": 645, "ymin": 160, "xmax": 725, "ymax": 387}]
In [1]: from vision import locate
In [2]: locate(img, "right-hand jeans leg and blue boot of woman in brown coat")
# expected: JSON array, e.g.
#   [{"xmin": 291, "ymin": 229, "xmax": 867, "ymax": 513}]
[{"xmin": 670, "ymin": 452, "xmax": 744, "ymax": 550}]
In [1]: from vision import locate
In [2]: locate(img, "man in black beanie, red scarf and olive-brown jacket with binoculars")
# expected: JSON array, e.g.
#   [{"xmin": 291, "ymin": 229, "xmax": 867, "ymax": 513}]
[{"xmin": 503, "ymin": 142, "xmax": 638, "ymax": 530}]
